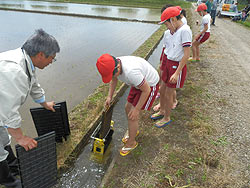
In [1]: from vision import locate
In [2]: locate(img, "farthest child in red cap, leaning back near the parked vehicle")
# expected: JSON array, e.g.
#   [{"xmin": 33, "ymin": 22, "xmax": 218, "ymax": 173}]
[{"xmin": 189, "ymin": 3, "xmax": 211, "ymax": 61}]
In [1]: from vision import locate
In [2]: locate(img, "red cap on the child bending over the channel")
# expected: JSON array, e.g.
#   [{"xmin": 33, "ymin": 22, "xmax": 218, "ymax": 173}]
[{"xmin": 96, "ymin": 54, "xmax": 115, "ymax": 83}]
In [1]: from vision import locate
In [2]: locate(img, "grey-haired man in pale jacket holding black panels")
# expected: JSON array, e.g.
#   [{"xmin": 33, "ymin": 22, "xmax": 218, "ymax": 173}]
[{"xmin": 0, "ymin": 29, "xmax": 60, "ymax": 188}]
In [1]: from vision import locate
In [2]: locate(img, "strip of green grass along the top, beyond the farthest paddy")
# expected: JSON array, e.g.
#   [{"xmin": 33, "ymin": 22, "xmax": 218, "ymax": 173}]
[{"xmin": 35, "ymin": 0, "xmax": 190, "ymax": 8}]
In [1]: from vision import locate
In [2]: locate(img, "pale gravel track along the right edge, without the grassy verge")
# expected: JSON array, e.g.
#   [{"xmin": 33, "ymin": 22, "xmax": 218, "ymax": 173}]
[{"xmin": 192, "ymin": 4, "xmax": 250, "ymax": 188}]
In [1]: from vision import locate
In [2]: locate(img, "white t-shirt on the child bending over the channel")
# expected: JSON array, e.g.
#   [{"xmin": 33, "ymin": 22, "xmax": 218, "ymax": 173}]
[{"xmin": 118, "ymin": 56, "xmax": 160, "ymax": 88}]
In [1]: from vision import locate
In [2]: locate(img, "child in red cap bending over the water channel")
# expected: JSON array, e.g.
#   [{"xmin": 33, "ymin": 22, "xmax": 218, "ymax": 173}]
[{"xmin": 96, "ymin": 54, "xmax": 159, "ymax": 156}]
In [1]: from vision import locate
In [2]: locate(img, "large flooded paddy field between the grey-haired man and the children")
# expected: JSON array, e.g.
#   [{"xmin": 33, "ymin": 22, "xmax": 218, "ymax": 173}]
[{"xmin": 0, "ymin": 11, "xmax": 159, "ymax": 137}]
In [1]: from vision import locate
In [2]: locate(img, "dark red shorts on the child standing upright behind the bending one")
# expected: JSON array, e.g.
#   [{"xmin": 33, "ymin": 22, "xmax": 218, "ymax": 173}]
[{"xmin": 161, "ymin": 59, "xmax": 187, "ymax": 88}]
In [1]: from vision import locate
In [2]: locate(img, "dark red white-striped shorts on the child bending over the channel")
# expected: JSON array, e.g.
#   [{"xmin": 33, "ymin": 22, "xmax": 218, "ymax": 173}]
[{"xmin": 127, "ymin": 84, "xmax": 159, "ymax": 110}]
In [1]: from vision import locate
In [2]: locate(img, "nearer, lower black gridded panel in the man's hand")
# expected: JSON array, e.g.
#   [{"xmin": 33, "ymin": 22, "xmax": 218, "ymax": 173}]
[{"xmin": 16, "ymin": 132, "xmax": 57, "ymax": 188}]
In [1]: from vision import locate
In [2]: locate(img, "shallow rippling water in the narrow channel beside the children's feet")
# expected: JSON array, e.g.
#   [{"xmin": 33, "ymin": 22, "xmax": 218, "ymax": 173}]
[{"xmin": 55, "ymin": 39, "xmax": 162, "ymax": 188}]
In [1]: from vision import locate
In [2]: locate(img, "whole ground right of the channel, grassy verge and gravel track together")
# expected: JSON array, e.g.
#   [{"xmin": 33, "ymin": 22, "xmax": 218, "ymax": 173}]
[{"xmin": 101, "ymin": 4, "xmax": 250, "ymax": 188}]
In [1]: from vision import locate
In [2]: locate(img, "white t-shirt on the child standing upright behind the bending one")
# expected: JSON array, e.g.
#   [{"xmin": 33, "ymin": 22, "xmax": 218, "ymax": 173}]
[{"xmin": 167, "ymin": 25, "xmax": 192, "ymax": 61}]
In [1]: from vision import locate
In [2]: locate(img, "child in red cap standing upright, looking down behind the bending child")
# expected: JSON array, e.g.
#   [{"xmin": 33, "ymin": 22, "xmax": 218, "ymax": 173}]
[{"xmin": 151, "ymin": 7, "xmax": 192, "ymax": 128}]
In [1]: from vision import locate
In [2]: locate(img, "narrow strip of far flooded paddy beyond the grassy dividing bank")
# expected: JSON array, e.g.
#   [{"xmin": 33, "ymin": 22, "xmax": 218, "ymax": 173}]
[{"xmin": 0, "ymin": 0, "xmax": 160, "ymax": 21}]
